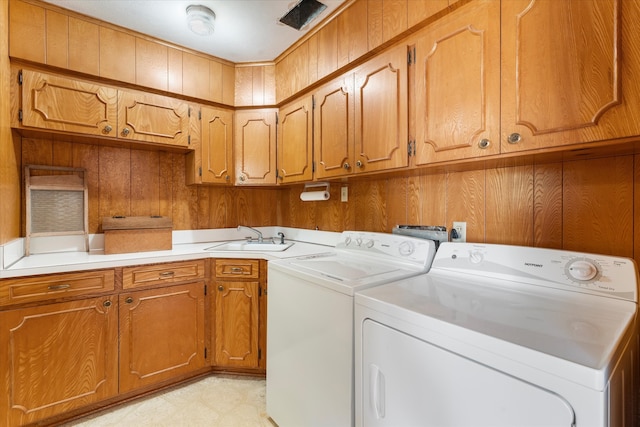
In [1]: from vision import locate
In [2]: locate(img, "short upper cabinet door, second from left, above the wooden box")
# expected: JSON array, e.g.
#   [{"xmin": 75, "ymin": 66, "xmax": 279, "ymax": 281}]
[{"xmin": 118, "ymin": 90, "xmax": 189, "ymax": 147}]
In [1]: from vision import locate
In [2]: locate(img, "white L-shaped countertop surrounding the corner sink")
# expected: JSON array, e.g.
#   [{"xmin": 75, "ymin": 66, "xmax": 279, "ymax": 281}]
[{"xmin": 0, "ymin": 227, "xmax": 340, "ymax": 278}]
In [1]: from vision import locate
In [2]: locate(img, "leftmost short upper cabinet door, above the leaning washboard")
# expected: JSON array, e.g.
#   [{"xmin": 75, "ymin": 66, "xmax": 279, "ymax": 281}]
[{"xmin": 21, "ymin": 70, "xmax": 118, "ymax": 137}]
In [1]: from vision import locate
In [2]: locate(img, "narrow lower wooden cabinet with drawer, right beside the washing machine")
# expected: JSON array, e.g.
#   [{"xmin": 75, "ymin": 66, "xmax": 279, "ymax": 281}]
[{"xmin": 211, "ymin": 259, "xmax": 266, "ymax": 371}]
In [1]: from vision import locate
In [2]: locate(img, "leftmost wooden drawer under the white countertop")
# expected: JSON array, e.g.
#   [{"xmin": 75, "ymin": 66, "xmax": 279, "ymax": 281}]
[{"xmin": 0, "ymin": 270, "xmax": 115, "ymax": 305}]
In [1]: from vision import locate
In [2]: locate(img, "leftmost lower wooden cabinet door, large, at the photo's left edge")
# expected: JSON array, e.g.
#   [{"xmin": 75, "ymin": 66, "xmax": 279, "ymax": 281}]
[{"xmin": 0, "ymin": 297, "xmax": 118, "ymax": 426}]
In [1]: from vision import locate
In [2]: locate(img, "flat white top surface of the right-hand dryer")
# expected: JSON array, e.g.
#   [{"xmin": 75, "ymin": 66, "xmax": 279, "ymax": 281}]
[{"xmin": 355, "ymin": 270, "xmax": 636, "ymax": 390}]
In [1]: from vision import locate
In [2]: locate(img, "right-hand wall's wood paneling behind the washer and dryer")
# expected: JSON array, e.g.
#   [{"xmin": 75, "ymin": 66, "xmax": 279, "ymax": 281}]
[{"xmin": 281, "ymin": 155, "xmax": 640, "ymax": 260}]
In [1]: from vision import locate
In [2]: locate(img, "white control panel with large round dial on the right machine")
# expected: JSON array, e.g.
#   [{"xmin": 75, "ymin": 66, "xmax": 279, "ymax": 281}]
[{"xmin": 432, "ymin": 242, "xmax": 638, "ymax": 302}]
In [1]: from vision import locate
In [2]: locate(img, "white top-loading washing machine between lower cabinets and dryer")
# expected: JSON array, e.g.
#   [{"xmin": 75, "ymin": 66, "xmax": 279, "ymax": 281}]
[{"xmin": 266, "ymin": 231, "xmax": 435, "ymax": 427}]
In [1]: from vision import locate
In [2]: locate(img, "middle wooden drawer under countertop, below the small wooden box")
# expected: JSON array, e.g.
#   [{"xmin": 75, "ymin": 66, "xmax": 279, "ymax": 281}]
[{"xmin": 122, "ymin": 260, "xmax": 205, "ymax": 289}]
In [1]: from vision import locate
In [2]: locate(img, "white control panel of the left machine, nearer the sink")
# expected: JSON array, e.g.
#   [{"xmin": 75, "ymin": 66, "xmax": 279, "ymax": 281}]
[{"xmin": 336, "ymin": 231, "xmax": 436, "ymax": 270}]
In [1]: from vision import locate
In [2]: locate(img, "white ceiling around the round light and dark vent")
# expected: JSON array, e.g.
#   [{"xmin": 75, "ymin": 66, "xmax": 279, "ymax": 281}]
[{"xmin": 40, "ymin": 0, "xmax": 345, "ymax": 62}]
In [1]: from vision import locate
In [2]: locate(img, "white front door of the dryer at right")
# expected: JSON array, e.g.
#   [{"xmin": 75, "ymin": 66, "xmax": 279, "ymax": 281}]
[{"xmin": 356, "ymin": 319, "xmax": 575, "ymax": 427}]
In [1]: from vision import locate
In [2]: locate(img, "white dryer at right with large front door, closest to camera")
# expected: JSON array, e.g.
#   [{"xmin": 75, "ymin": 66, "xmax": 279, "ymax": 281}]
[{"xmin": 355, "ymin": 243, "xmax": 638, "ymax": 427}]
